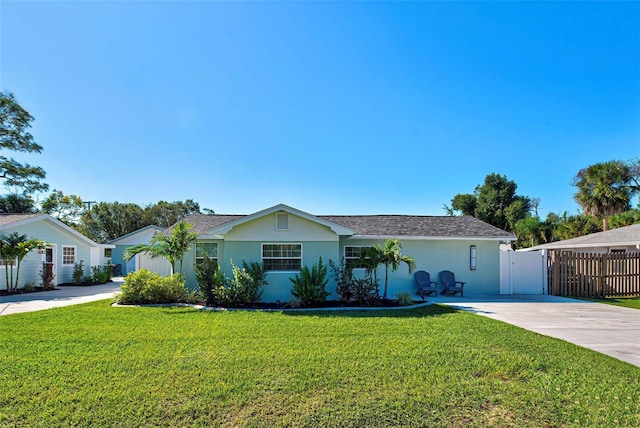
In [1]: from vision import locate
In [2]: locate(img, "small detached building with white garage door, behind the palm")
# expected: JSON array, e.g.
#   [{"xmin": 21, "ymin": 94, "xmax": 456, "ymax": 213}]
[{"xmin": 108, "ymin": 225, "xmax": 171, "ymax": 275}]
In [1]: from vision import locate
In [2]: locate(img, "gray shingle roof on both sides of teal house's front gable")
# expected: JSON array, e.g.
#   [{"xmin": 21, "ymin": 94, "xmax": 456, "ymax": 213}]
[{"xmin": 185, "ymin": 214, "xmax": 515, "ymax": 240}]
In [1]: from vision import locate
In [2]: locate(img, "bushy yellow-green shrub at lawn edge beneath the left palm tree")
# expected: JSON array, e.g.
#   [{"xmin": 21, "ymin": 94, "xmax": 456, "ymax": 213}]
[{"xmin": 117, "ymin": 269, "xmax": 186, "ymax": 305}]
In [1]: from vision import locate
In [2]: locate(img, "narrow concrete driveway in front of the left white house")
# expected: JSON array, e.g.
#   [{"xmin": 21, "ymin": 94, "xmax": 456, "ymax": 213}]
[{"xmin": 0, "ymin": 278, "xmax": 122, "ymax": 315}]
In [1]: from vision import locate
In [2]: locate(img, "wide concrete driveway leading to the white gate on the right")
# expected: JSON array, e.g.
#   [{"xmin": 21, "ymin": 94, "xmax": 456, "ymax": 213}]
[{"xmin": 432, "ymin": 296, "xmax": 640, "ymax": 367}]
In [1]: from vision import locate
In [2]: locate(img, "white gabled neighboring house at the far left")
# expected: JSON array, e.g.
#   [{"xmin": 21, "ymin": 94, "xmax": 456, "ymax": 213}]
[{"xmin": 0, "ymin": 214, "xmax": 115, "ymax": 290}]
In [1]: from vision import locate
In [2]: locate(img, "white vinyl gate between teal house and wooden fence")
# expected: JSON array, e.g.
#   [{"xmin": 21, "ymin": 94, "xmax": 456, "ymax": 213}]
[{"xmin": 500, "ymin": 251, "xmax": 547, "ymax": 294}]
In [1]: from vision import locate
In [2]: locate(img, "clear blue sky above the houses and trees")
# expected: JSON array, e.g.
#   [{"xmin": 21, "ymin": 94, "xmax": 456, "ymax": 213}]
[{"xmin": 0, "ymin": 1, "xmax": 640, "ymax": 216}]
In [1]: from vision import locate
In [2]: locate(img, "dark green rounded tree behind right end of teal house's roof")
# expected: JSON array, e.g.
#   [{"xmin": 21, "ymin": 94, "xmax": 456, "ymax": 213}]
[{"xmin": 444, "ymin": 173, "xmax": 531, "ymax": 231}]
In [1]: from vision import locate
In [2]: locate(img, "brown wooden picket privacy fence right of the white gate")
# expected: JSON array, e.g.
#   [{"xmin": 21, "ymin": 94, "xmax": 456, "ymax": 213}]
[{"xmin": 547, "ymin": 251, "xmax": 640, "ymax": 298}]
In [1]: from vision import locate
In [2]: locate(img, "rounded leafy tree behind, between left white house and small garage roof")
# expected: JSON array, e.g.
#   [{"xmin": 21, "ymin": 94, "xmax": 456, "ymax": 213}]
[{"xmin": 78, "ymin": 202, "xmax": 148, "ymax": 243}]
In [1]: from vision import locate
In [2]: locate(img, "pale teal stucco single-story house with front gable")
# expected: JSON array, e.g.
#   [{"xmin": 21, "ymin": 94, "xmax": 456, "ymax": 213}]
[{"xmin": 169, "ymin": 204, "xmax": 516, "ymax": 302}]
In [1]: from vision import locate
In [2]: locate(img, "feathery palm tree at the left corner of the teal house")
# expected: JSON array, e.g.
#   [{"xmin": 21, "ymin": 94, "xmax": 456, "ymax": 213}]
[{"xmin": 123, "ymin": 221, "xmax": 198, "ymax": 275}]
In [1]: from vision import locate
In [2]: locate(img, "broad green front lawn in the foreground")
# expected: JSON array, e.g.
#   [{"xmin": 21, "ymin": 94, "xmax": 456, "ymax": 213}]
[{"xmin": 0, "ymin": 301, "xmax": 640, "ymax": 427}]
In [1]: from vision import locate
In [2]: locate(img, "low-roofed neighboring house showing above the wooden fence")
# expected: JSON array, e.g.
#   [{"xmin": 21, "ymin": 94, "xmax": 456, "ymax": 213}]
[{"xmin": 522, "ymin": 224, "xmax": 640, "ymax": 253}]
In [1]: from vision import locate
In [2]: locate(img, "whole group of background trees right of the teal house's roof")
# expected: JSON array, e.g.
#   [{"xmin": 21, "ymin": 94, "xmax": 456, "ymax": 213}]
[{"xmin": 444, "ymin": 160, "xmax": 640, "ymax": 248}]
